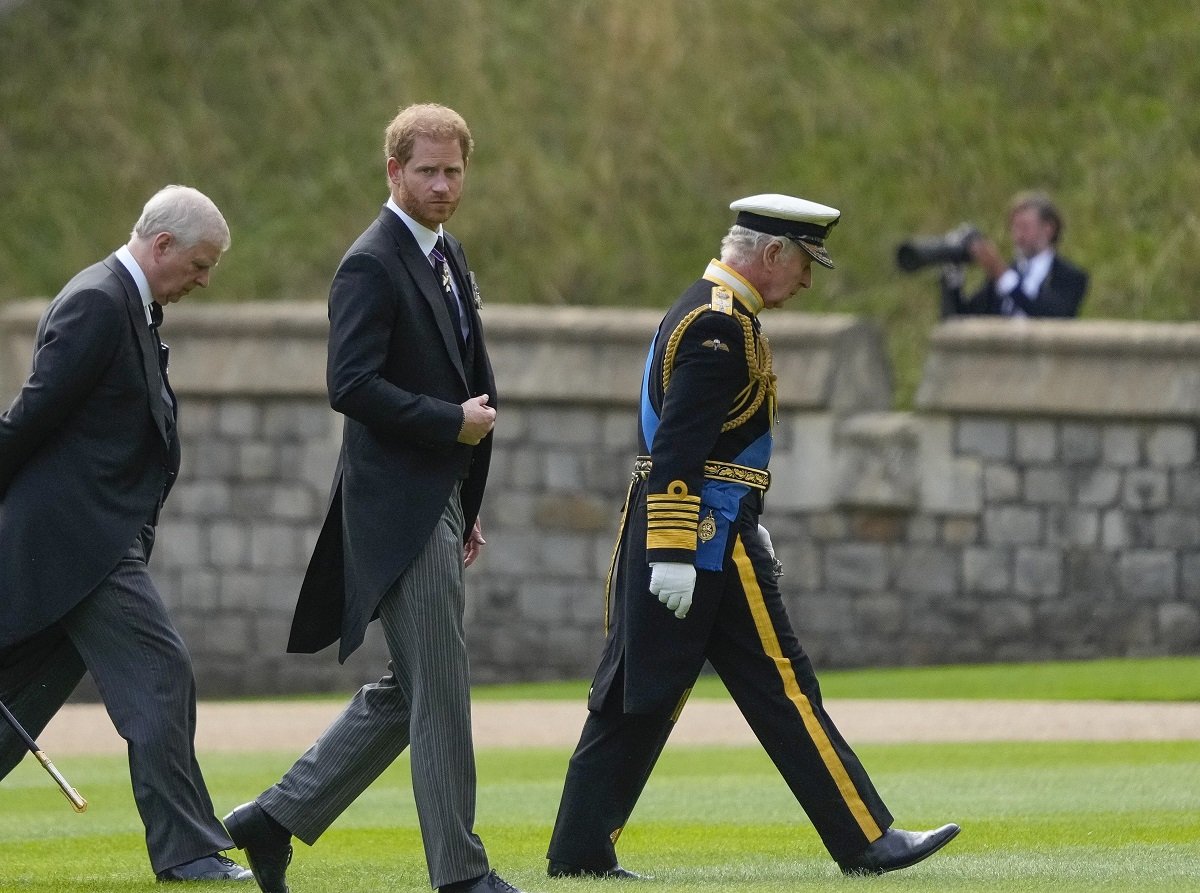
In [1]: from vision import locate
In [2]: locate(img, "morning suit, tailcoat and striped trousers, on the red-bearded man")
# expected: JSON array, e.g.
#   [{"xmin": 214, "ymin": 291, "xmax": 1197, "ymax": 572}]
[{"xmin": 253, "ymin": 206, "xmax": 496, "ymax": 887}]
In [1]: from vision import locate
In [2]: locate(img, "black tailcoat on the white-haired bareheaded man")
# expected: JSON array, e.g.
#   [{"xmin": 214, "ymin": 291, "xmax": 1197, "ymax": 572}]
[{"xmin": 0, "ymin": 254, "xmax": 179, "ymax": 648}]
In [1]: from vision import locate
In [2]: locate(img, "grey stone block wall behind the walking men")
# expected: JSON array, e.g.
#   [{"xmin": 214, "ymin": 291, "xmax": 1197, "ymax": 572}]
[{"xmin": 0, "ymin": 302, "xmax": 1200, "ymax": 696}]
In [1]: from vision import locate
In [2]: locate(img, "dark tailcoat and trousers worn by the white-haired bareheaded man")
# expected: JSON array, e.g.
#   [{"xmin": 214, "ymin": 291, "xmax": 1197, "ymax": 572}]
[{"xmin": 0, "ymin": 254, "xmax": 232, "ymax": 871}]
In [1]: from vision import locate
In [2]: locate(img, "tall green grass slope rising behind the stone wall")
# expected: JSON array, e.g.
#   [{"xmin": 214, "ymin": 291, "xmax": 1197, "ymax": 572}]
[{"xmin": 0, "ymin": 0, "xmax": 1200, "ymax": 402}]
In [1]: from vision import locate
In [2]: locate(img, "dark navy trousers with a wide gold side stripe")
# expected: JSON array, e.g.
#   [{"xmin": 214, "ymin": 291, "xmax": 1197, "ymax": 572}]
[{"xmin": 547, "ymin": 511, "xmax": 892, "ymax": 871}]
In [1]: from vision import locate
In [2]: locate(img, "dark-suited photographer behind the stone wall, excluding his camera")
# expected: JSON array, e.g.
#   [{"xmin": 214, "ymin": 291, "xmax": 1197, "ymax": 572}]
[{"xmin": 941, "ymin": 192, "xmax": 1087, "ymax": 319}]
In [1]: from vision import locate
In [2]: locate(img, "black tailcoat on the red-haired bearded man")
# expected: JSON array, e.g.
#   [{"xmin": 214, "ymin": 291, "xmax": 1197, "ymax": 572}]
[{"xmin": 288, "ymin": 206, "xmax": 496, "ymax": 661}]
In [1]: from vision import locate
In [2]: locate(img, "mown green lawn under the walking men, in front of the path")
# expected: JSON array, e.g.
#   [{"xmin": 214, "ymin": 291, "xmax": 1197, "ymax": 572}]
[{"xmin": 0, "ymin": 742, "xmax": 1200, "ymax": 893}]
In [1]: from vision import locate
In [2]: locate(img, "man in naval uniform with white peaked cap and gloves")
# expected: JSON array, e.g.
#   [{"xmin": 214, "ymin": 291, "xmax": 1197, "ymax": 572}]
[{"xmin": 547, "ymin": 194, "xmax": 959, "ymax": 877}]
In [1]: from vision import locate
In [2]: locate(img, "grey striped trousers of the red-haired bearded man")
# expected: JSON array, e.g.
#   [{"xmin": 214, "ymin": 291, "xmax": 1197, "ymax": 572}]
[{"xmin": 257, "ymin": 490, "xmax": 488, "ymax": 887}]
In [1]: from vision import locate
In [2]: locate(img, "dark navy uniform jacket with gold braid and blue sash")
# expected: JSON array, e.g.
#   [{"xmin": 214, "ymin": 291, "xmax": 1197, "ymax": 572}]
[{"xmin": 589, "ymin": 260, "xmax": 775, "ymax": 713}]
